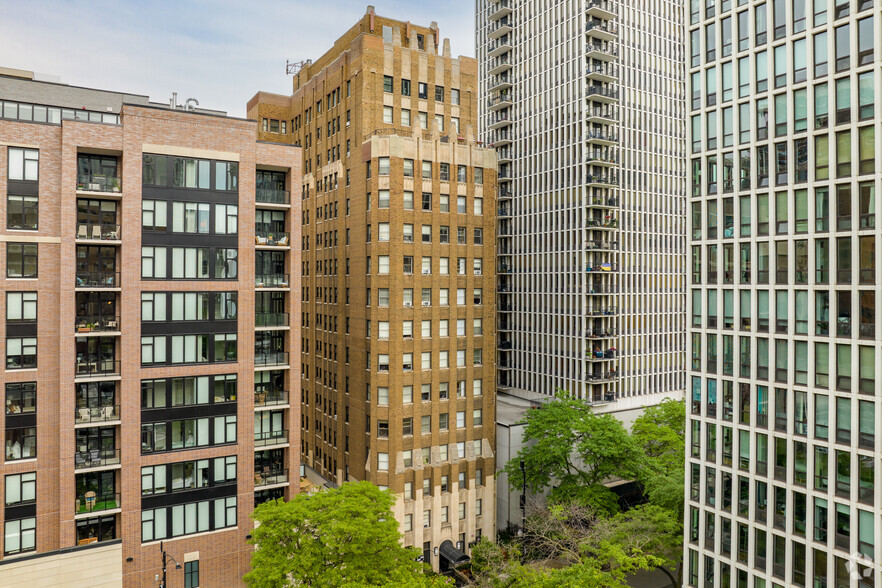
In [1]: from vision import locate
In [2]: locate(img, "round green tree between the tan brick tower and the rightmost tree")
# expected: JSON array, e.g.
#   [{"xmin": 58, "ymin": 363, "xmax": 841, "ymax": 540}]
[{"xmin": 505, "ymin": 390, "xmax": 641, "ymax": 513}]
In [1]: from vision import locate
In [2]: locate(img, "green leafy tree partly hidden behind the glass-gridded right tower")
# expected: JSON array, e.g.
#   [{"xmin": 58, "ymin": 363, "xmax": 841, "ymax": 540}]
[{"xmin": 631, "ymin": 399, "xmax": 686, "ymax": 521}]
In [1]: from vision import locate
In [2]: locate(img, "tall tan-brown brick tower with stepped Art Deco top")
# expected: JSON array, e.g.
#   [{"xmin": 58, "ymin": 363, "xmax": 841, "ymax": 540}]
[{"xmin": 248, "ymin": 7, "xmax": 496, "ymax": 569}]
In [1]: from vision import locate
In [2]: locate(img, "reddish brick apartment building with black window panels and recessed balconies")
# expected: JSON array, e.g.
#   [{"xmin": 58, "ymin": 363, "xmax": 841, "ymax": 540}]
[{"xmin": 0, "ymin": 70, "xmax": 301, "ymax": 586}]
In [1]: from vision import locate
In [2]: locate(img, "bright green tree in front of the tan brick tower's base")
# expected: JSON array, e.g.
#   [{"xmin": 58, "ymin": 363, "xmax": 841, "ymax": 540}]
[{"xmin": 245, "ymin": 482, "xmax": 450, "ymax": 588}]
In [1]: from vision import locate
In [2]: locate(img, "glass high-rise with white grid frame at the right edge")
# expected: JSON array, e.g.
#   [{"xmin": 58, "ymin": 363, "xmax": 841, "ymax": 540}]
[{"xmin": 685, "ymin": 0, "xmax": 882, "ymax": 588}]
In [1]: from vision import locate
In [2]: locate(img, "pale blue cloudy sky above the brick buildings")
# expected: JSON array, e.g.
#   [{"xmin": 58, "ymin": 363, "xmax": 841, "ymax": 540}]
[{"xmin": 0, "ymin": 0, "xmax": 475, "ymax": 116}]
